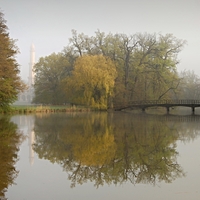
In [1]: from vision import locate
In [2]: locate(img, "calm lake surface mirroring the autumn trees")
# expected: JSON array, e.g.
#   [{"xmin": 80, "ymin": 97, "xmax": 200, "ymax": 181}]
[{"xmin": 0, "ymin": 112, "xmax": 200, "ymax": 200}]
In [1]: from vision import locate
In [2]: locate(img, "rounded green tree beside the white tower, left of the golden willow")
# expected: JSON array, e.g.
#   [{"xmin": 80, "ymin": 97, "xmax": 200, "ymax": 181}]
[{"xmin": 33, "ymin": 53, "xmax": 72, "ymax": 105}]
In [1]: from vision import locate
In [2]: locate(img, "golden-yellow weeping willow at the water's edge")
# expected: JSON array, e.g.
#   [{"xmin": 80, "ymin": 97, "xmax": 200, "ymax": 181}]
[{"xmin": 64, "ymin": 55, "xmax": 117, "ymax": 109}]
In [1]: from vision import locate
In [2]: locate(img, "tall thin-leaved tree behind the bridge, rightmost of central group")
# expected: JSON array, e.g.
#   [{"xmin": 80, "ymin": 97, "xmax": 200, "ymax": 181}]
[{"xmin": 126, "ymin": 34, "xmax": 185, "ymax": 100}]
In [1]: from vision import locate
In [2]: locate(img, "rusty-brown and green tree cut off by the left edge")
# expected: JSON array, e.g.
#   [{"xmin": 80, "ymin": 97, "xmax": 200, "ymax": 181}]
[{"xmin": 0, "ymin": 12, "xmax": 25, "ymax": 110}]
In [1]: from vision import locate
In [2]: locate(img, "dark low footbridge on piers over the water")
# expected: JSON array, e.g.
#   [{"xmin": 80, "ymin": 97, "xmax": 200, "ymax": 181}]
[{"xmin": 114, "ymin": 99, "xmax": 200, "ymax": 114}]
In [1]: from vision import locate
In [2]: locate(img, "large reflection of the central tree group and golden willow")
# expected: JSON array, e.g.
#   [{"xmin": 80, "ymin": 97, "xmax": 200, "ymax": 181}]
[{"xmin": 31, "ymin": 113, "xmax": 200, "ymax": 187}]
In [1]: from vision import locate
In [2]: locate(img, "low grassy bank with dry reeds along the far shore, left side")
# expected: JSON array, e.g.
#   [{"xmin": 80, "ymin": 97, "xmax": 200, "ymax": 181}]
[{"xmin": 0, "ymin": 105, "xmax": 91, "ymax": 114}]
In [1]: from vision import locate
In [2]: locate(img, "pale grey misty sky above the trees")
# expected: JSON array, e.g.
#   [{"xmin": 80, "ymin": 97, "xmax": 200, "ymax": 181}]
[{"xmin": 0, "ymin": 0, "xmax": 200, "ymax": 80}]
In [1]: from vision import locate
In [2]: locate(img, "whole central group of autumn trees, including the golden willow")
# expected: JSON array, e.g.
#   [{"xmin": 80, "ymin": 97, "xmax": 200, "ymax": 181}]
[{"xmin": 33, "ymin": 30, "xmax": 198, "ymax": 109}]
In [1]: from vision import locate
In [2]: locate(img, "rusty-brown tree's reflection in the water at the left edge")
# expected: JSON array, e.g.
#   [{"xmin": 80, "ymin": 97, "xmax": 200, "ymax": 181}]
[{"xmin": 0, "ymin": 117, "xmax": 22, "ymax": 200}]
